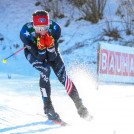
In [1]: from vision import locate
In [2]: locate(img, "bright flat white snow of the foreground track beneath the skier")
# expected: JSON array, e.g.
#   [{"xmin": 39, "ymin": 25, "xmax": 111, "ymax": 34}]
[{"xmin": 0, "ymin": 74, "xmax": 134, "ymax": 134}]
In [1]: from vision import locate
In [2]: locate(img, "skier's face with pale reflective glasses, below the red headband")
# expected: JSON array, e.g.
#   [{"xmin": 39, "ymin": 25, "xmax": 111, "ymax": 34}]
[{"xmin": 34, "ymin": 25, "xmax": 49, "ymax": 35}]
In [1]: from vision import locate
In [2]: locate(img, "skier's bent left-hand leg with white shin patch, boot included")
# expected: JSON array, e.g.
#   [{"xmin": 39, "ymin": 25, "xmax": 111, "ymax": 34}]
[{"xmin": 26, "ymin": 50, "xmax": 59, "ymax": 120}]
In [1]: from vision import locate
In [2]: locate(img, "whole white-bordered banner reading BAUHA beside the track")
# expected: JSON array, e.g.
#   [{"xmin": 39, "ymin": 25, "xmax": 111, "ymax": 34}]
[{"xmin": 98, "ymin": 44, "xmax": 134, "ymax": 83}]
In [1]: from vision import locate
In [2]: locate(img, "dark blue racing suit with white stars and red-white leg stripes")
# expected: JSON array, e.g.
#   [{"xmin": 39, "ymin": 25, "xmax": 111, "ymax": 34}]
[{"xmin": 20, "ymin": 20, "xmax": 87, "ymax": 118}]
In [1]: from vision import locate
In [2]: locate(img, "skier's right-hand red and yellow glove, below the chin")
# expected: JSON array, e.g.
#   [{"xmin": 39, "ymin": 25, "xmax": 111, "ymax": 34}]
[{"xmin": 44, "ymin": 33, "xmax": 54, "ymax": 48}]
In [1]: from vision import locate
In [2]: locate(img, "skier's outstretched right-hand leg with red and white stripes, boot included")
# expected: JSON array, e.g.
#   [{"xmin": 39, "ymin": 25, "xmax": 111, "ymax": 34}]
[{"xmin": 50, "ymin": 53, "xmax": 88, "ymax": 118}]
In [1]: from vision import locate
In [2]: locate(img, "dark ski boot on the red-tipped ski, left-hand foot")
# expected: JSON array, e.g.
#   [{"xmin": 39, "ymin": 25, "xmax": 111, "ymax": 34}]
[{"xmin": 44, "ymin": 97, "xmax": 61, "ymax": 122}]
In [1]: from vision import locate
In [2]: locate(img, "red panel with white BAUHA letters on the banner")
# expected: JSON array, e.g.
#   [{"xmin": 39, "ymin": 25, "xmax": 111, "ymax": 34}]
[{"xmin": 99, "ymin": 49, "xmax": 134, "ymax": 76}]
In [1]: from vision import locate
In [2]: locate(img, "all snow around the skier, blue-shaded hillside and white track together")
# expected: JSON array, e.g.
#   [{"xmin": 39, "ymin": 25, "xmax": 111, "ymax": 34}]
[{"xmin": 0, "ymin": 0, "xmax": 134, "ymax": 134}]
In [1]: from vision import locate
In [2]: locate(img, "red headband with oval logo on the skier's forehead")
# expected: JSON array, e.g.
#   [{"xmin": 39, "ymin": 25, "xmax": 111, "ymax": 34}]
[{"xmin": 33, "ymin": 16, "xmax": 49, "ymax": 26}]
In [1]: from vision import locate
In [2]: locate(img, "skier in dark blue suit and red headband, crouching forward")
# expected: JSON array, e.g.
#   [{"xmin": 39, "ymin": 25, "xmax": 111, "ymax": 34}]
[{"xmin": 20, "ymin": 10, "xmax": 89, "ymax": 120}]
